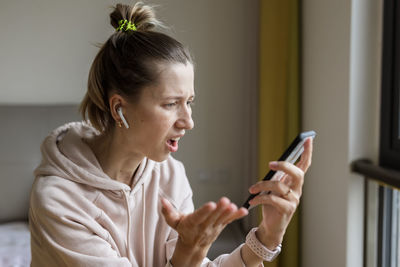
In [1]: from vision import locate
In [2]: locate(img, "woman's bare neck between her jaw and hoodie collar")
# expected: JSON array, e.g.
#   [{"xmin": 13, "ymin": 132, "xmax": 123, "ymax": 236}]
[{"xmin": 88, "ymin": 130, "xmax": 144, "ymax": 186}]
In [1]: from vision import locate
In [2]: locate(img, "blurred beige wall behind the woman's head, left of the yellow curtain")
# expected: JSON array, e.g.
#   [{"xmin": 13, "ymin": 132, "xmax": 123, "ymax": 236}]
[{"xmin": 0, "ymin": 0, "xmax": 258, "ymax": 209}]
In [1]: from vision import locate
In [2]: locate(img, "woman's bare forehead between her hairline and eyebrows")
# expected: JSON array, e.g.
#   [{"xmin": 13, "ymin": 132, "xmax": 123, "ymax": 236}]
[{"xmin": 146, "ymin": 62, "xmax": 194, "ymax": 98}]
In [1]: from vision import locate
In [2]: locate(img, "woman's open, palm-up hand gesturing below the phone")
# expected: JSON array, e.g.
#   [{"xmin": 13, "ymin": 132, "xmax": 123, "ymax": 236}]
[{"xmin": 161, "ymin": 197, "xmax": 248, "ymax": 267}]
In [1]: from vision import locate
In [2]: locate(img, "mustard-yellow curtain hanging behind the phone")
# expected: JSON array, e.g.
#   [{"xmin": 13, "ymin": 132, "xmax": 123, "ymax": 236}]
[{"xmin": 259, "ymin": 0, "xmax": 300, "ymax": 267}]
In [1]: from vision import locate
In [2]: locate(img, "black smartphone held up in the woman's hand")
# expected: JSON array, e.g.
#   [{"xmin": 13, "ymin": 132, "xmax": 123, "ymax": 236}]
[{"xmin": 243, "ymin": 131, "xmax": 316, "ymax": 209}]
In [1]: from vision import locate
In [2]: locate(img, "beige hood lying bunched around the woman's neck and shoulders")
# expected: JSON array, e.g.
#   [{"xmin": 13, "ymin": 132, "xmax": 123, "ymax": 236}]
[{"xmin": 34, "ymin": 122, "xmax": 154, "ymax": 191}]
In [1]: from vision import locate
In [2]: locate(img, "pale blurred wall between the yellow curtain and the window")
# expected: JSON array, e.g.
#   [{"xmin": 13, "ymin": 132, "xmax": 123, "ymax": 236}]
[{"xmin": 302, "ymin": 0, "xmax": 382, "ymax": 267}]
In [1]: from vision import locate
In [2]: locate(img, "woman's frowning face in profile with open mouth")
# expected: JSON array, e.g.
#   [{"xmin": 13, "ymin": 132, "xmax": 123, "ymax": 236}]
[{"xmin": 123, "ymin": 63, "xmax": 194, "ymax": 161}]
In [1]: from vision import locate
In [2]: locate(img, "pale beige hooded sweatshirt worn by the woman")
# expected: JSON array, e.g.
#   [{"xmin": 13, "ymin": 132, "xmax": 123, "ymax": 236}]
[{"xmin": 29, "ymin": 122, "xmax": 244, "ymax": 267}]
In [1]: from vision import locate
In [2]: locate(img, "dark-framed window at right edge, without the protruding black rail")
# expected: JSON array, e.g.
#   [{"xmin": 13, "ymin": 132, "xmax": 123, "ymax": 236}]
[{"xmin": 377, "ymin": 0, "xmax": 400, "ymax": 267}]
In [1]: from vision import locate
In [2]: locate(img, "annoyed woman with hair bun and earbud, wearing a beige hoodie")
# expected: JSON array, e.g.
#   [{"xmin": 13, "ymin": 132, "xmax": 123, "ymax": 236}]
[{"xmin": 29, "ymin": 3, "xmax": 312, "ymax": 267}]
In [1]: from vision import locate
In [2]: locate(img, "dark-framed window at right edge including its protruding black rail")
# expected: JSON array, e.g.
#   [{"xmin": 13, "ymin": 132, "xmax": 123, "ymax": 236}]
[{"xmin": 352, "ymin": 0, "xmax": 400, "ymax": 267}]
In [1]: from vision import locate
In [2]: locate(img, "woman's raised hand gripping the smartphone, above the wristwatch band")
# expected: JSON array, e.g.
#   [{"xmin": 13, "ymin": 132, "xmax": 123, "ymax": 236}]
[{"xmin": 249, "ymin": 138, "xmax": 312, "ymax": 249}]
